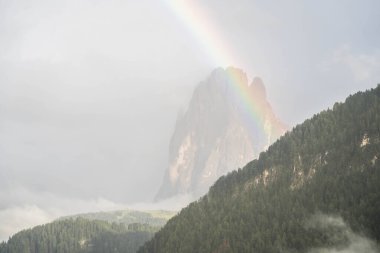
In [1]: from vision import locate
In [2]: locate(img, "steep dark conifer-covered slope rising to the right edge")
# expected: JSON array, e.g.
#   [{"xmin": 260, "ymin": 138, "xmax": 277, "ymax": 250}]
[{"xmin": 138, "ymin": 85, "xmax": 380, "ymax": 253}]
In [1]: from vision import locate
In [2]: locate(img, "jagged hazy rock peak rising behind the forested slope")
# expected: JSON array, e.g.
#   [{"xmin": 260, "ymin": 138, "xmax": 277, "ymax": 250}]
[{"xmin": 156, "ymin": 68, "xmax": 286, "ymax": 202}]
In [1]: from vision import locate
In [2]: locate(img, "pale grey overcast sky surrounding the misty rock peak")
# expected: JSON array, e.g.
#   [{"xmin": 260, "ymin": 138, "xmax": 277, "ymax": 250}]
[{"xmin": 0, "ymin": 0, "xmax": 380, "ymax": 240}]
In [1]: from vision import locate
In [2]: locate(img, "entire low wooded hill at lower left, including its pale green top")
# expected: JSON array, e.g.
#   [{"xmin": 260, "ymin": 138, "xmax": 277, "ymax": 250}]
[{"xmin": 0, "ymin": 210, "xmax": 175, "ymax": 253}]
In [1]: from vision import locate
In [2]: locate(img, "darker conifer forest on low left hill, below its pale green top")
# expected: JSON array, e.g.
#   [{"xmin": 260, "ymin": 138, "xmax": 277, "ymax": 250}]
[{"xmin": 0, "ymin": 218, "xmax": 158, "ymax": 253}]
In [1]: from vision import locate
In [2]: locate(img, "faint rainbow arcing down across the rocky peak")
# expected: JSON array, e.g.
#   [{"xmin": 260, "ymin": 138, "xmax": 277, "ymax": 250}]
[{"xmin": 166, "ymin": 0, "xmax": 271, "ymax": 140}]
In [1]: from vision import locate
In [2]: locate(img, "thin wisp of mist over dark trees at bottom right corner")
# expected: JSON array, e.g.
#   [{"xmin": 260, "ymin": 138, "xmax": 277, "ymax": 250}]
[{"xmin": 306, "ymin": 214, "xmax": 380, "ymax": 253}]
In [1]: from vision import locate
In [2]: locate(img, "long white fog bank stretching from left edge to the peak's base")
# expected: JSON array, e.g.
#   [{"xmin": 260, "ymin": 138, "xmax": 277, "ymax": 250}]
[{"xmin": 0, "ymin": 187, "xmax": 193, "ymax": 242}]
